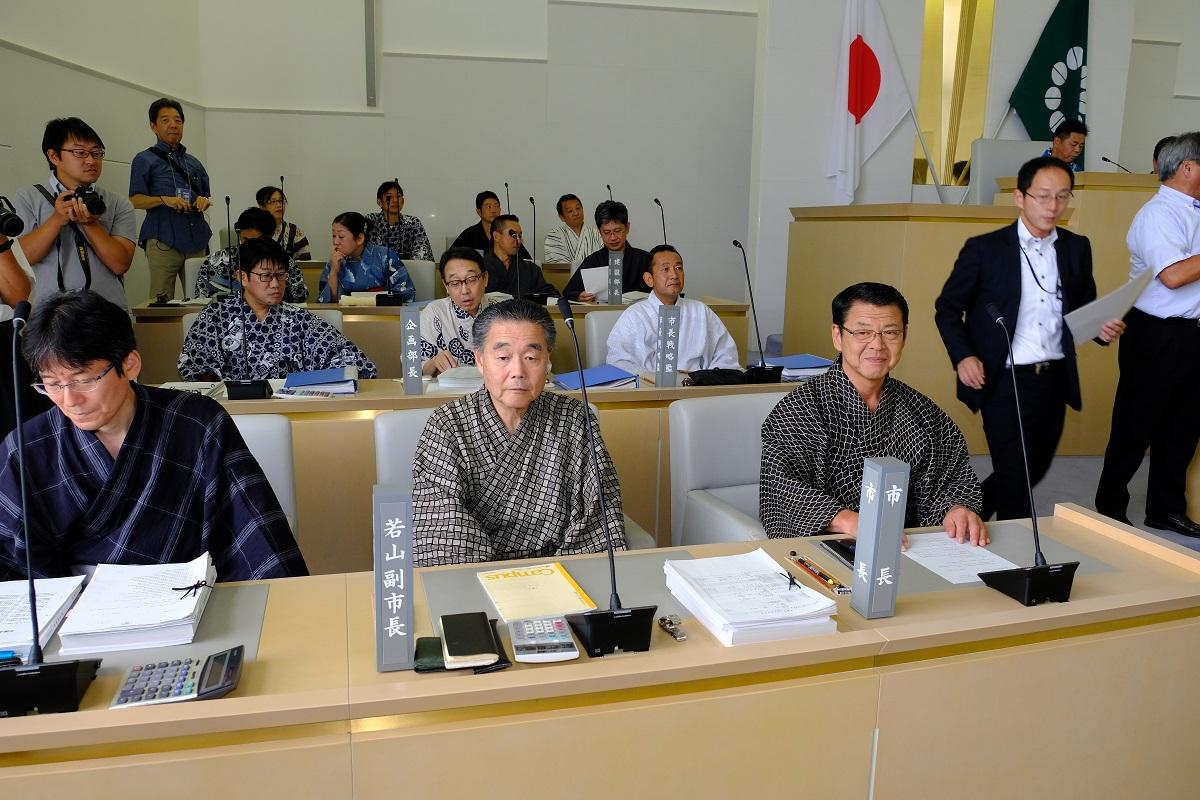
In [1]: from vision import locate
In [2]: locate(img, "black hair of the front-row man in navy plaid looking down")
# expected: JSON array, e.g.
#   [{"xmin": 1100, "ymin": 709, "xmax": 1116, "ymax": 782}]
[{"xmin": 22, "ymin": 289, "xmax": 137, "ymax": 375}]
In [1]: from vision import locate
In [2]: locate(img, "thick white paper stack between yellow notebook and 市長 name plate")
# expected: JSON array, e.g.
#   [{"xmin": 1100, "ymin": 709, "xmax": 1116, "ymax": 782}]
[{"xmin": 662, "ymin": 548, "xmax": 838, "ymax": 646}]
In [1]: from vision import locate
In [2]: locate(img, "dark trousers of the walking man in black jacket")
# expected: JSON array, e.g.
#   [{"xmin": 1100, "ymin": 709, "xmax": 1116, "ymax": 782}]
[{"xmin": 979, "ymin": 361, "xmax": 1067, "ymax": 519}]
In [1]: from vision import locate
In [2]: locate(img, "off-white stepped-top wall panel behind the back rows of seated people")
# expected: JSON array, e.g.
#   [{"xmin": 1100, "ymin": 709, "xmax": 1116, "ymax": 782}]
[{"xmin": 206, "ymin": 4, "xmax": 755, "ymax": 297}]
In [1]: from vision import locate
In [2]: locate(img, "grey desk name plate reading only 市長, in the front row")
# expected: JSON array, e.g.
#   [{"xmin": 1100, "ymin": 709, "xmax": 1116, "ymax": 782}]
[{"xmin": 850, "ymin": 458, "xmax": 908, "ymax": 619}]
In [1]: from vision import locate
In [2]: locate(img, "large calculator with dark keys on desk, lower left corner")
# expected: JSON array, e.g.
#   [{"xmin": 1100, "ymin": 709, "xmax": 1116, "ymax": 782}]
[{"xmin": 109, "ymin": 644, "xmax": 246, "ymax": 709}]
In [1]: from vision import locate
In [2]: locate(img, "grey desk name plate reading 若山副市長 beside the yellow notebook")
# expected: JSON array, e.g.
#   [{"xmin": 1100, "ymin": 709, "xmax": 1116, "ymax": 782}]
[{"xmin": 371, "ymin": 483, "xmax": 413, "ymax": 672}]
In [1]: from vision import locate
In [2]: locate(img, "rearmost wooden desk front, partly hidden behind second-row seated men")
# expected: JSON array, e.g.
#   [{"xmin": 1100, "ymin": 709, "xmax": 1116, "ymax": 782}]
[{"xmin": 133, "ymin": 298, "xmax": 749, "ymax": 384}]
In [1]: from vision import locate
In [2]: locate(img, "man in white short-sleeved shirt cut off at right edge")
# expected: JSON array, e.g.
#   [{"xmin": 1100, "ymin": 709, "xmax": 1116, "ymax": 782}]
[{"xmin": 1096, "ymin": 131, "xmax": 1200, "ymax": 536}]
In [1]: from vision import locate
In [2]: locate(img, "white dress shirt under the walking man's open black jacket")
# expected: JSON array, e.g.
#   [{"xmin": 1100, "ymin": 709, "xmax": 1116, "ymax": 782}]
[{"xmin": 1013, "ymin": 219, "xmax": 1063, "ymax": 365}]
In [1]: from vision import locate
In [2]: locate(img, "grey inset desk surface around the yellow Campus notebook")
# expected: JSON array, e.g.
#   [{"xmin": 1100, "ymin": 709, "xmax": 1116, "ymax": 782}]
[{"xmin": 420, "ymin": 551, "xmax": 691, "ymax": 631}]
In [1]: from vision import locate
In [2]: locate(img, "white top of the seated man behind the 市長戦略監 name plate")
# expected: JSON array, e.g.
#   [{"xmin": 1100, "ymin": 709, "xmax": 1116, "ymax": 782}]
[{"xmin": 608, "ymin": 291, "xmax": 740, "ymax": 374}]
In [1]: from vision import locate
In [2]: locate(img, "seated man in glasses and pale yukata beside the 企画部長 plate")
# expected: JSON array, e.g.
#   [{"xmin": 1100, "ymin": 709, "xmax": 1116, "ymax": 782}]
[{"xmin": 421, "ymin": 247, "xmax": 497, "ymax": 377}]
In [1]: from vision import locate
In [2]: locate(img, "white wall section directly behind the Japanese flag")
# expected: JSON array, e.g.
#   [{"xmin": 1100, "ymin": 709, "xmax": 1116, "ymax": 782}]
[{"xmin": 750, "ymin": 0, "xmax": 924, "ymax": 338}]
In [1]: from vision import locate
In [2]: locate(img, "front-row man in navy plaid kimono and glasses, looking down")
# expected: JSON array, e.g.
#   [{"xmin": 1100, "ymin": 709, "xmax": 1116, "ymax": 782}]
[{"xmin": 0, "ymin": 290, "xmax": 308, "ymax": 581}]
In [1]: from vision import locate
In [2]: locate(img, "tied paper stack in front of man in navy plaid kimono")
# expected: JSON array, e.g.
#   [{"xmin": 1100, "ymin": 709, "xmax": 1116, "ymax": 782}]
[{"xmin": 59, "ymin": 553, "xmax": 217, "ymax": 656}]
